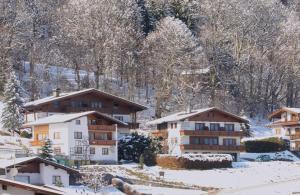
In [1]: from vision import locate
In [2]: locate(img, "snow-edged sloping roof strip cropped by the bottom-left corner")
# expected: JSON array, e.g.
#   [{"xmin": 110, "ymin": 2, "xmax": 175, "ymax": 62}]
[{"xmin": 0, "ymin": 178, "xmax": 64, "ymax": 195}]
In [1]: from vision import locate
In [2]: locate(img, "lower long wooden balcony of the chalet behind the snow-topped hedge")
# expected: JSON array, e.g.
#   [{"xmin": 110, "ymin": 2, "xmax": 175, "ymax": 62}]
[{"xmin": 180, "ymin": 144, "xmax": 245, "ymax": 151}]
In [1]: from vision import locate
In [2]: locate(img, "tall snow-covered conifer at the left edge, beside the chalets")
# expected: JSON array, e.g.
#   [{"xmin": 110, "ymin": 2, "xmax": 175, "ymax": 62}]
[{"xmin": 1, "ymin": 70, "xmax": 24, "ymax": 134}]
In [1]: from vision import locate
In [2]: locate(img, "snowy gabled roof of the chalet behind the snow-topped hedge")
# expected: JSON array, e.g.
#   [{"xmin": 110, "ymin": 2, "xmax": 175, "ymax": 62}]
[{"xmin": 147, "ymin": 107, "xmax": 248, "ymax": 125}]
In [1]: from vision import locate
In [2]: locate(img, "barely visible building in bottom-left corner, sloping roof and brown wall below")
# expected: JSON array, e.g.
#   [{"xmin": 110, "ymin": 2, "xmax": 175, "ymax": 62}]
[{"xmin": 0, "ymin": 178, "xmax": 65, "ymax": 195}]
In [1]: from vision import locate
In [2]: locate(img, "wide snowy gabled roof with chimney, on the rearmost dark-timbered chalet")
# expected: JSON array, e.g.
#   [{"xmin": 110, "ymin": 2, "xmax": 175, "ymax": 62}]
[{"xmin": 24, "ymin": 88, "xmax": 147, "ymax": 111}]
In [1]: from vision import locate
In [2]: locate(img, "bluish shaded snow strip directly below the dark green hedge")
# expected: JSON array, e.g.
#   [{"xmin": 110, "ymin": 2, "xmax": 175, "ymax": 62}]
[{"xmin": 240, "ymin": 150, "xmax": 300, "ymax": 161}]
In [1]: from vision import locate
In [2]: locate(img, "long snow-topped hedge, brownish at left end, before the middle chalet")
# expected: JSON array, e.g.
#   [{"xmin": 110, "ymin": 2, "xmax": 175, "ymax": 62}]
[{"xmin": 156, "ymin": 154, "xmax": 233, "ymax": 170}]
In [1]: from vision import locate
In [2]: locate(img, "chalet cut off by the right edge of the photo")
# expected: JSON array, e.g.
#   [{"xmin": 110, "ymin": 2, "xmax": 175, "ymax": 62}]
[{"xmin": 268, "ymin": 107, "xmax": 300, "ymax": 152}]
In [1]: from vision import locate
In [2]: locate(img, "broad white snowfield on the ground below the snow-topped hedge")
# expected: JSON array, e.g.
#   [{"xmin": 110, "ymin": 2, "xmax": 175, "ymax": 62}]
[{"xmin": 105, "ymin": 161, "xmax": 300, "ymax": 189}]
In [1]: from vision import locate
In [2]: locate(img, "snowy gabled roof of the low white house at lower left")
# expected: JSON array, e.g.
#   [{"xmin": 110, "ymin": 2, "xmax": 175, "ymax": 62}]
[{"xmin": 0, "ymin": 156, "xmax": 79, "ymax": 173}]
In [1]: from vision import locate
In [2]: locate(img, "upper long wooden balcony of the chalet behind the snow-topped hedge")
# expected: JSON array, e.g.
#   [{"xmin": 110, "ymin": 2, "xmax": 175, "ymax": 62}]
[{"xmin": 180, "ymin": 130, "xmax": 243, "ymax": 137}]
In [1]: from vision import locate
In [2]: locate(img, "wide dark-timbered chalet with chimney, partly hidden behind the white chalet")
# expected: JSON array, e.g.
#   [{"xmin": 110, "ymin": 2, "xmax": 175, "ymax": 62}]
[{"xmin": 24, "ymin": 88, "xmax": 147, "ymax": 129}]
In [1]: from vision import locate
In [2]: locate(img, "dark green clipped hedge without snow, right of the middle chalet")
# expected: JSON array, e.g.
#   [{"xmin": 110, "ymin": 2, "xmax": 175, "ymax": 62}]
[{"xmin": 244, "ymin": 137, "xmax": 288, "ymax": 153}]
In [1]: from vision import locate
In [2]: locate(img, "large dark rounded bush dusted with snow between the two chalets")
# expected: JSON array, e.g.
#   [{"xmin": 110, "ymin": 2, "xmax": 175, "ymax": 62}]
[{"xmin": 118, "ymin": 133, "xmax": 162, "ymax": 166}]
